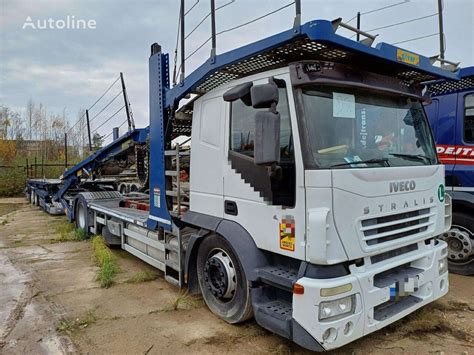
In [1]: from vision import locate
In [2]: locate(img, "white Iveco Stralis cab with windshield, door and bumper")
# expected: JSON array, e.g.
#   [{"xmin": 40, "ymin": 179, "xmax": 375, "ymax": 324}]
[{"xmin": 185, "ymin": 62, "xmax": 450, "ymax": 349}]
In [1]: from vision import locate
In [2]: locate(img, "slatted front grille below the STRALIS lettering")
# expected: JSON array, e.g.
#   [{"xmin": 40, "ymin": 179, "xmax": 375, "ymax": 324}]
[{"xmin": 360, "ymin": 208, "xmax": 434, "ymax": 246}]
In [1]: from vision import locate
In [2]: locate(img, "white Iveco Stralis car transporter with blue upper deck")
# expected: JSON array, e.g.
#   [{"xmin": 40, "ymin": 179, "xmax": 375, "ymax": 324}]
[{"xmin": 68, "ymin": 16, "xmax": 455, "ymax": 351}]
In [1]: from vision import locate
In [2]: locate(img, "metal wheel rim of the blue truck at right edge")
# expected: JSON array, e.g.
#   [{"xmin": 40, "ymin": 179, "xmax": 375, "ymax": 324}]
[{"xmin": 441, "ymin": 225, "xmax": 474, "ymax": 262}]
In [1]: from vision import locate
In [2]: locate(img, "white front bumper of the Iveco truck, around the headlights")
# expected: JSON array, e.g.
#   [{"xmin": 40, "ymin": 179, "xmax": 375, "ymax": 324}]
[{"xmin": 293, "ymin": 240, "xmax": 449, "ymax": 350}]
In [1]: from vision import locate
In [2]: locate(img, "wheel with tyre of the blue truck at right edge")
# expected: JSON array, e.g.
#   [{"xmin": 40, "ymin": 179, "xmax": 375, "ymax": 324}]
[{"xmin": 441, "ymin": 212, "xmax": 474, "ymax": 275}]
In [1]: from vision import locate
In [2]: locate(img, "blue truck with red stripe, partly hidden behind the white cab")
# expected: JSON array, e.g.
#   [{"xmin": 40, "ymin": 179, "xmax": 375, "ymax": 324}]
[{"xmin": 425, "ymin": 66, "xmax": 474, "ymax": 275}]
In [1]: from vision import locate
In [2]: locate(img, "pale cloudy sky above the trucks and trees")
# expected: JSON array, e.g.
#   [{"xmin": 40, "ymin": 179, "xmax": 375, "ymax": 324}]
[{"xmin": 0, "ymin": 0, "xmax": 474, "ymax": 142}]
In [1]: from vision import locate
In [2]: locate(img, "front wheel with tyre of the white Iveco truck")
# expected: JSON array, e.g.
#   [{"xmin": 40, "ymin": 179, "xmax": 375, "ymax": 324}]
[{"xmin": 197, "ymin": 234, "xmax": 253, "ymax": 323}]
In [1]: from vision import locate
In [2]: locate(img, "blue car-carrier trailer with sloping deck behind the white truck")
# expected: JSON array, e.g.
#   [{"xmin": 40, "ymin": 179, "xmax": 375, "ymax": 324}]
[{"xmin": 25, "ymin": 128, "xmax": 149, "ymax": 217}]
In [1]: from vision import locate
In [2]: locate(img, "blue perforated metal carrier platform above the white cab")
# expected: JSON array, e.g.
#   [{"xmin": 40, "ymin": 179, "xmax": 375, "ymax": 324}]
[{"xmin": 165, "ymin": 19, "xmax": 458, "ymax": 107}]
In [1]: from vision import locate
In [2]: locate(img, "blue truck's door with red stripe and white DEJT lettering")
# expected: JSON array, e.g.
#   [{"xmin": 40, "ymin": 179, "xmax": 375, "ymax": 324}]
[{"xmin": 453, "ymin": 91, "xmax": 474, "ymax": 190}]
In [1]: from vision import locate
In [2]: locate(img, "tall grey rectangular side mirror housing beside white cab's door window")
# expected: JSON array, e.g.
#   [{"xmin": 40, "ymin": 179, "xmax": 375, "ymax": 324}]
[{"xmin": 254, "ymin": 112, "xmax": 280, "ymax": 165}]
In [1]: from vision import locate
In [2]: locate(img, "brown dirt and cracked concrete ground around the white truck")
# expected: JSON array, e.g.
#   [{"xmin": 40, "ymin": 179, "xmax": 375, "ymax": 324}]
[{"xmin": 0, "ymin": 198, "xmax": 474, "ymax": 354}]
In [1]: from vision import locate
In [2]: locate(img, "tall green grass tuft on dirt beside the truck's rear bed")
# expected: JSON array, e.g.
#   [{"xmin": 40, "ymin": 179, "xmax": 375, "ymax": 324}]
[{"xmin": 92, "ymin": 235, "xmax": 120, "ymax": 288}]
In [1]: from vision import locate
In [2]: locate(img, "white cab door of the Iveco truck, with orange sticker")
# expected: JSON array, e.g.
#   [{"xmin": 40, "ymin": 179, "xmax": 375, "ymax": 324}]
[{"xmin": 224, "ymin": 76, "xmax": 305, "ymax": 259}]
